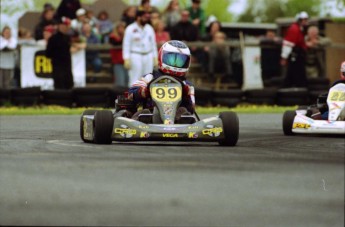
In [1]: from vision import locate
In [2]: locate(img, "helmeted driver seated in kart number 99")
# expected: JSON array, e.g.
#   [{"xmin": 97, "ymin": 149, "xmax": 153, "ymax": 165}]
[{"xmin": 128, "ymin": 40, "xmax": 195, "ymax": 122}]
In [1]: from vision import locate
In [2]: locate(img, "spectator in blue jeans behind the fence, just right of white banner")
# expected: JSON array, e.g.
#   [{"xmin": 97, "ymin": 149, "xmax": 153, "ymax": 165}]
[{"xmin": 81, "ymin": 23, "xmax": 102, "ymax": 73}]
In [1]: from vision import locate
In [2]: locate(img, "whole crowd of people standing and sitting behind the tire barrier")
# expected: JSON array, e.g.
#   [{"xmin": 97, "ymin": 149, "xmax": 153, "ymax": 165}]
[{"xmin": 0, "ymin": 0, "xmax": 326, "ymax": 89}]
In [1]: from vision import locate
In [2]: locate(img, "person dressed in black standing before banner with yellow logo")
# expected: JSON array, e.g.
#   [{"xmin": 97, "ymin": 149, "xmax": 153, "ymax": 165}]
[{"xmin": 46, "ymin": 17, "xmax": 73, "ymax": 89}]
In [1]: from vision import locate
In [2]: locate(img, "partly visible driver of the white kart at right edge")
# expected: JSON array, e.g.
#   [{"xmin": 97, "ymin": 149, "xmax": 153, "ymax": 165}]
[{"xmin": 311, "ymin": 61, "xmax": 345, "ymax": 120}]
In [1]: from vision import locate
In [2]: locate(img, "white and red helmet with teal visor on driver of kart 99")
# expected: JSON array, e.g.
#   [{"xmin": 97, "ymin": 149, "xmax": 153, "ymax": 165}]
[{"xmin": 158, "ymin": 40, "xmax": 191, "ymax": 77}]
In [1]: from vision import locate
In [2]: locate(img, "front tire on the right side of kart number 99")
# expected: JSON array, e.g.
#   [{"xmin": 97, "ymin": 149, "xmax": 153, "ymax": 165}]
[{"xmin": 219, "ymin": 112, "xmax": 239, "ymax": 146}]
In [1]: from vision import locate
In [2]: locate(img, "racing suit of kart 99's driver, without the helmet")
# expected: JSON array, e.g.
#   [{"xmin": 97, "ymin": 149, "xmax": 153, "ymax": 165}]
[{"xmin": 128, "ymin": 70, "xmax": 195, "ymax": 115}]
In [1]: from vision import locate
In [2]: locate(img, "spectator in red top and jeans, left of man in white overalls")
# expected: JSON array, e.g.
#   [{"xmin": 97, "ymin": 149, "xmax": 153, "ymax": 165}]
[{"xmin": 109, "ymin": 21, "xmax": 128, "ymax": 87}]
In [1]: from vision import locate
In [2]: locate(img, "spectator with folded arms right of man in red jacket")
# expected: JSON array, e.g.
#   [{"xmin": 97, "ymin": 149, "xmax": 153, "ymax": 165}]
[{"xmin": 306, "ymin": 26, "xmax": 329, "ymax": 78}]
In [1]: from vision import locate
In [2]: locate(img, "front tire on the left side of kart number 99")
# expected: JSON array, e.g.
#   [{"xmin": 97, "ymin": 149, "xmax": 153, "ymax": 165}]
[{"xmin": 93, "ymin": 110, "xmax": 114, "ymax": 144}]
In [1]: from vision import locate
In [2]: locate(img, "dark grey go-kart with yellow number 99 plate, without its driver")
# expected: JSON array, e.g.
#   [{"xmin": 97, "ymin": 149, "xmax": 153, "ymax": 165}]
[{"xmin": 80, "ymin": 75, "xmax": 239, "ymax": 146}]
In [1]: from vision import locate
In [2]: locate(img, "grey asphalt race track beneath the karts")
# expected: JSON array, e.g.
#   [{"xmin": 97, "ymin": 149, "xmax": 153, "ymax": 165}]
[{"xmin": 0, "ymin": 114, "xmax": 345, "ymax": 227}]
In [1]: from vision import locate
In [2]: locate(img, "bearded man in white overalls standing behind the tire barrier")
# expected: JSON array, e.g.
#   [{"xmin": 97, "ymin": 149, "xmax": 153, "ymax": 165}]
[{"xmin": 122, "ymin": 10, "xmax": 158, "ymax": 87}]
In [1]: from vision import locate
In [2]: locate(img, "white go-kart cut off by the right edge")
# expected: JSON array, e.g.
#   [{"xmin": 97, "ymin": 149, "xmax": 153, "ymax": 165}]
[{"xmin": 283, "ymin": 83, "xmax": 345, "ymax": 135}]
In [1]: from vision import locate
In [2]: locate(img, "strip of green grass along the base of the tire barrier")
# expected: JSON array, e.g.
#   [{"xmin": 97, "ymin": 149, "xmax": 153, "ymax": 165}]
[{"xmin": 0, "ymin": 105, "xmax": 296, "ymax": 115}]
